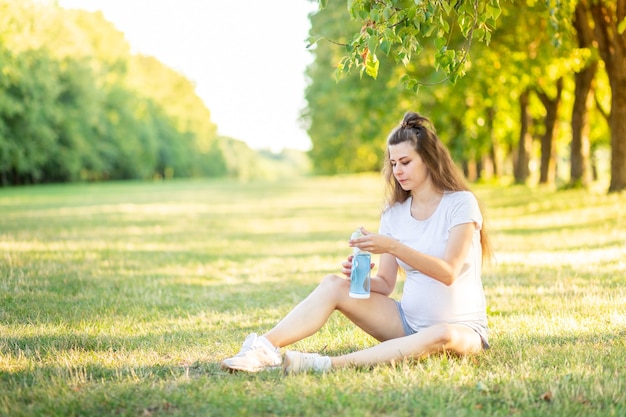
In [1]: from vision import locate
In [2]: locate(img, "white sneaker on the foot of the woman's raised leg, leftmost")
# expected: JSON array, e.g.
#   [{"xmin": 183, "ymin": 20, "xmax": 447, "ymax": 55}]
[{"xmin": 222, "ymin": 333, "xmax": 283, "ymax": 372}]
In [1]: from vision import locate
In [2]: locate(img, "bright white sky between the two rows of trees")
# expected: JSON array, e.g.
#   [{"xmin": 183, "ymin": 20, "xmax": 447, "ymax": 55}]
[{"xmin": 58, "ymin": 0, "xmax": 317, "ymax": 150}]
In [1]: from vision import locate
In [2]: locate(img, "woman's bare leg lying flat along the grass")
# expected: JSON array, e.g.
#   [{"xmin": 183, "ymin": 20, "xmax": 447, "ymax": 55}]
[{"xmin": 331, "ymin": 324, "xmax": 482, "ymax": 368}]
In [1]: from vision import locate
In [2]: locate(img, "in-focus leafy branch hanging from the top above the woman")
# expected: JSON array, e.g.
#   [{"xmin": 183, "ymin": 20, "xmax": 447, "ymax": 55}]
[{"xmin": 319, "ymin": 0, "xmax": 501, "ymax": 91}]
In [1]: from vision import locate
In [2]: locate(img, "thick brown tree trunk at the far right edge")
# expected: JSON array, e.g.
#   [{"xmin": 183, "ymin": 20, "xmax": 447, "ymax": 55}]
[{"xmin": 588, "ymin": 0, "xmax": 626, "ymax": 192}]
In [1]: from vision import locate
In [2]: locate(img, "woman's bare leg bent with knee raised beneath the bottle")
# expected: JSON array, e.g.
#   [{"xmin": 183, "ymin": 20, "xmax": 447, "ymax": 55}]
[{"xmin": 264, "ymin": 275, "xmax": 404, "ymax": 347}]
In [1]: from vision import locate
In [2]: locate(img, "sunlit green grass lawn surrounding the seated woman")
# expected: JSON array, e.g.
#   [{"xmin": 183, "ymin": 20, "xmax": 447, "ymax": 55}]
[{"xmin": 0, "ymin": 176, "xmax": 626, "ymax": 417}]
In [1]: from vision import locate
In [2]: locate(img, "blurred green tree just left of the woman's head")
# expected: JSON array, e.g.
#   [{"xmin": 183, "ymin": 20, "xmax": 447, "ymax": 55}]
[{"xmin": 303, "ymin": 3, "xmax": 403, "ymax": 174}]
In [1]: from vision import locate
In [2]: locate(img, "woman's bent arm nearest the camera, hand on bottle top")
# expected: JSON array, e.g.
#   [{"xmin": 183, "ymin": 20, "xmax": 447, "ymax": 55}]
[{"xmin": 351, "ymin": 222, "xmax": 476, "ymax": 285}]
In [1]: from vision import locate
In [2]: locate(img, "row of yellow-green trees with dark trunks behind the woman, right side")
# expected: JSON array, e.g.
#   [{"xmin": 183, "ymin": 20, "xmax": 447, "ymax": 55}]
[{"xmin": 303, "ymin": 0, "xmax": 626, "ymax": 191}]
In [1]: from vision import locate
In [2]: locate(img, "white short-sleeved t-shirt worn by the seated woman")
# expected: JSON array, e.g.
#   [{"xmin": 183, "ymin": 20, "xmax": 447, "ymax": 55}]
[{"xmin": 379, "ymin": 191, "xmax": 487, "ymax": 330}]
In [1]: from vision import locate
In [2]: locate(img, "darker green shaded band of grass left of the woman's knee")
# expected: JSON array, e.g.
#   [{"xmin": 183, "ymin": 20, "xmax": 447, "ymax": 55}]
[{"xmin": 0, "ymin": 271, "xmax": 314, "ymax": 327}]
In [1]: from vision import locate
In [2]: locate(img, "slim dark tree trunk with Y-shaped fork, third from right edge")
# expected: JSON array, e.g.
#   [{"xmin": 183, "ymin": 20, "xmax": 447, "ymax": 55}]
[{"xmin": 537, "ymin": 77, "xmax": 563, "ymax": 184}]
